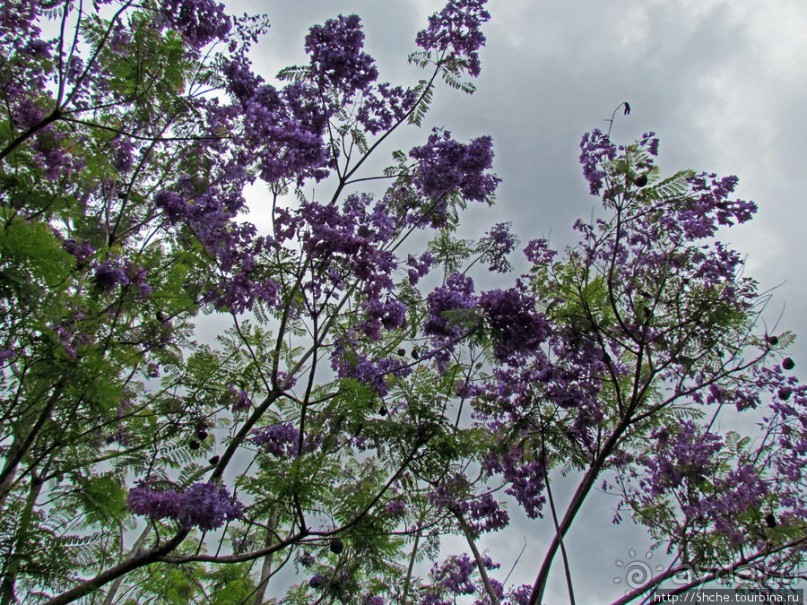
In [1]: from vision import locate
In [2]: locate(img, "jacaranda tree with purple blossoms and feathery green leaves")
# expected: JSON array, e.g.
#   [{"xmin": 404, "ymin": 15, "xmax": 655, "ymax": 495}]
[{"xmin": 0, "ymin": 0, "xmax": 807, "ymax": 605}]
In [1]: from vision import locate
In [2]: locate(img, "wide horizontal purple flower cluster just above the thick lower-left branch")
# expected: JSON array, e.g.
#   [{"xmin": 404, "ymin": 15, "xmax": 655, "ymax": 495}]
[{"xmin": 127, "ymin": 479, "xmax": 244, "ymax": 531}]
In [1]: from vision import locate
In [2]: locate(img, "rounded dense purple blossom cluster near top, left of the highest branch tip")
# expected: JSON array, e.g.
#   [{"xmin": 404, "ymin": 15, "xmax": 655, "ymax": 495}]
[{"xmin": 305, "ymin": 15, "xmax": 378, "ymax": 95}]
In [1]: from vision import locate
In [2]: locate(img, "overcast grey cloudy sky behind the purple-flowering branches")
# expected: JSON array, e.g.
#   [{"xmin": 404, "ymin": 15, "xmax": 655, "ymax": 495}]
[{"xmin": 227, "ymin": 0, "xmax": 807, "ymax": 603}]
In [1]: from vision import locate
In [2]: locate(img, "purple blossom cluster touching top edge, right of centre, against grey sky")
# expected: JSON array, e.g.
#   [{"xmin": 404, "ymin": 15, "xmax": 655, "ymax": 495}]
[{"xmin": 415, "ymin": 0, "xmax": 490, "ymax": 76}]
